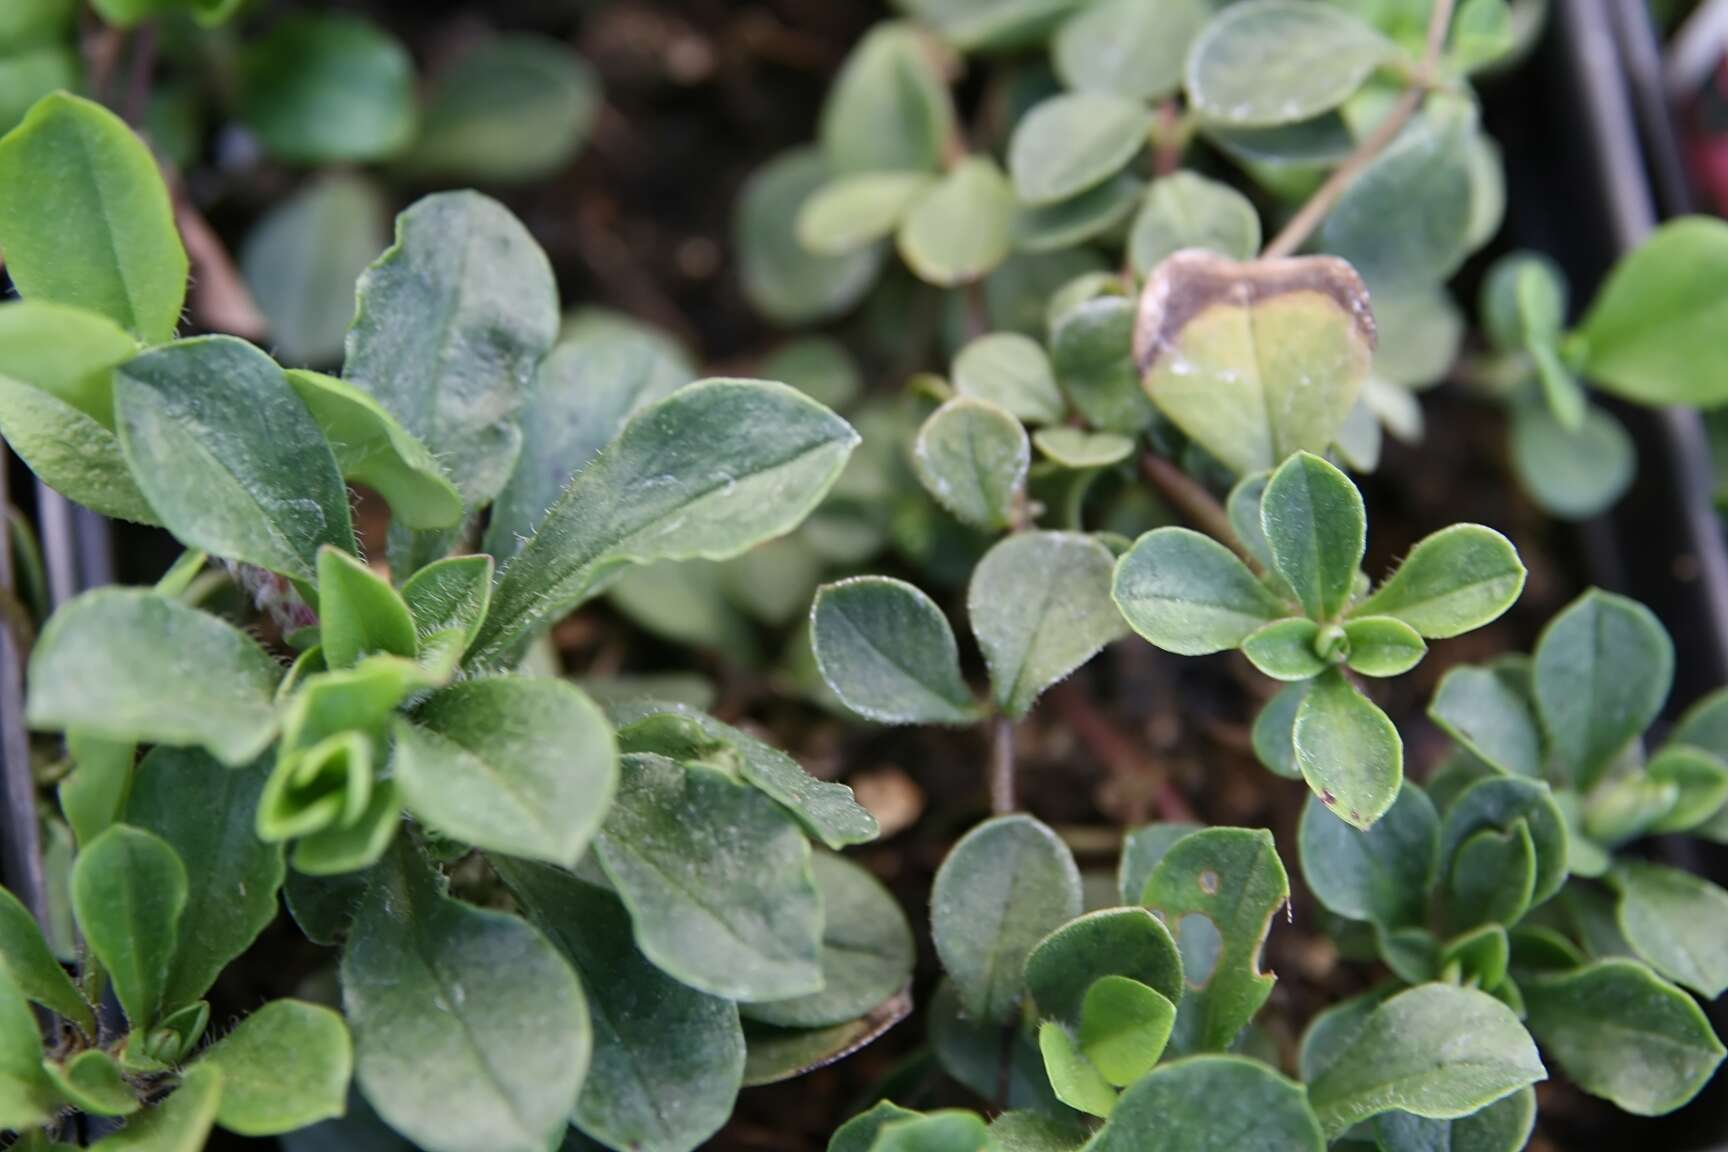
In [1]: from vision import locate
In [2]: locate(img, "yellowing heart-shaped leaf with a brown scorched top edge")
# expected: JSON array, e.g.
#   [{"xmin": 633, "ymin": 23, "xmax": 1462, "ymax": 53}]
[{"xmin": 1134, "ymin": 250, "xmax": 1374, "ymax": 473}]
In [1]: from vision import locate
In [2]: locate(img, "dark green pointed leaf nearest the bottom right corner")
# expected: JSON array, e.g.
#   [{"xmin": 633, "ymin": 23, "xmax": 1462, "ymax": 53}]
[{"xmin": 1519, "ymin": 960, "xmax": 1723, "ymax": 1116}]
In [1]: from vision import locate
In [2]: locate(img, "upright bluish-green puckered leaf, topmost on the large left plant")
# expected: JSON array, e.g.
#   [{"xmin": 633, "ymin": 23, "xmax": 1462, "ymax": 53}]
[{"xmin": 342, "ymin": 192, "xmax": 558, "ymax": 510}]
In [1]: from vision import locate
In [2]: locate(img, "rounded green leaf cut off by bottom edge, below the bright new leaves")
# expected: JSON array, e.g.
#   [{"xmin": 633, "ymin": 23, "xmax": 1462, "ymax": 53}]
[{"xmin": 1094, "ymin": 1055, "xmax": 1325, "ymax": 1152}]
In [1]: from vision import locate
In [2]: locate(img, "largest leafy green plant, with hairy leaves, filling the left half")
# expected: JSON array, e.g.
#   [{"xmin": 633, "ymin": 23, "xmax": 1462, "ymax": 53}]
[{"xmin": 0, "ymin": 97, "xmax": 912, "ymax": 1152}]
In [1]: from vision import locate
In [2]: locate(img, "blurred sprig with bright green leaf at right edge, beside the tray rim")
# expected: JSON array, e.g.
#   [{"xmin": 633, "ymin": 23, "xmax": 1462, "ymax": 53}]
[{"xmin": 1469, "ymin": 216, "xmax": 1728, "ymax": 520}]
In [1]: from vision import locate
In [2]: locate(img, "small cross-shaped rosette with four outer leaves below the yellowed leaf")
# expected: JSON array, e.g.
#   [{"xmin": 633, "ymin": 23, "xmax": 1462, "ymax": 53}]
[{"xmin": 1111, "ymin": 453, "xmax": 1524, "ymax": 827}]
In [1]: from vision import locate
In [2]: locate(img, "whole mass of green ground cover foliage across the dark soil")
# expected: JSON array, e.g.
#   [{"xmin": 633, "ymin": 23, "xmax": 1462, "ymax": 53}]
[{"xmin": 0, "ymin": 0, "xmax": 1728, "ymax": 1152}]
